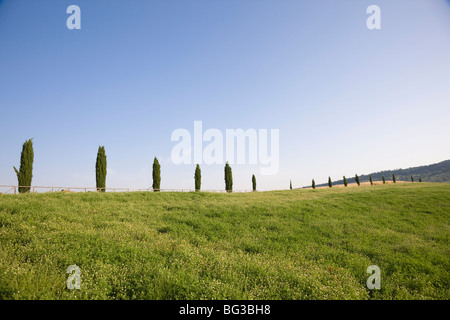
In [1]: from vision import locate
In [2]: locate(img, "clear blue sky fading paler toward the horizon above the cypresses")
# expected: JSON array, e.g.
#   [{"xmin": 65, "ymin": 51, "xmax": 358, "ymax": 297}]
[{"xmin": 0, "ymin": 0, "xmax": 450, "ymax": 190}]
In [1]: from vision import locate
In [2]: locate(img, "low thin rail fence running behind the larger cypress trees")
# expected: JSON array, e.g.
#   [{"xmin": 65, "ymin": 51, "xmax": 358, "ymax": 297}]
[{"xmin": 0, "ymin": 185, "xmax": 252, "ymax": 194}]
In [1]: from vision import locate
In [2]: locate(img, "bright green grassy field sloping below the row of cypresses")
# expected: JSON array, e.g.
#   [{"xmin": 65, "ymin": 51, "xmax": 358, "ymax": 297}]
[{"xmin": 0, "ymin": 183, "xmax": 450, "ymax": 299}]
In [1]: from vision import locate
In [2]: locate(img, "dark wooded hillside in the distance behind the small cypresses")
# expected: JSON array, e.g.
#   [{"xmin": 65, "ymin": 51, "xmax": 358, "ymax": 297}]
[{"xmin": 316, "ymin": 160, "xmax": 450, "ymax": 187}]
